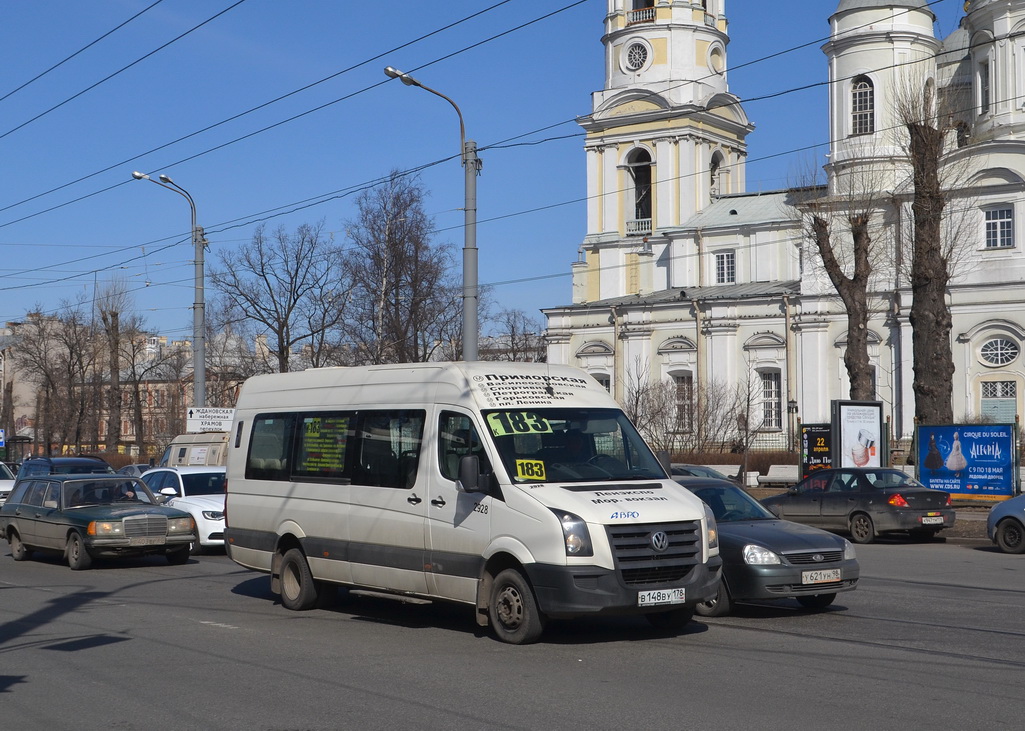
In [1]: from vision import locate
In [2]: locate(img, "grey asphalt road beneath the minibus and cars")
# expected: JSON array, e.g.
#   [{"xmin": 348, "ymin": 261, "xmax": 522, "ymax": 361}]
[{"xmin": 0, "ymin": 540, "xmax": 1025, "ymax": 731}]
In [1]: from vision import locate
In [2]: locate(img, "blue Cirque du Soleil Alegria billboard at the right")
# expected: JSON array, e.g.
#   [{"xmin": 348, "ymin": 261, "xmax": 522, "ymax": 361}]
[{"xmin": 915, "ymin": 423, "xmax": 1018, "ymax": 500}]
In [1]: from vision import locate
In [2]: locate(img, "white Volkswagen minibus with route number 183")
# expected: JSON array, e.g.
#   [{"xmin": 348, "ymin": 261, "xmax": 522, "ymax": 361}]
[{"xmin": 224, "ymin": 362, "xmax": 722, "ymax": 644}]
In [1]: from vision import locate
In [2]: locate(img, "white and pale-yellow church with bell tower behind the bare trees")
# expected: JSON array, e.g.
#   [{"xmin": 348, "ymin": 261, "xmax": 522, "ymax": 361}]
[{"xmin": 543, "ymin": 0, "xmax": 1025, "ymax": 447}]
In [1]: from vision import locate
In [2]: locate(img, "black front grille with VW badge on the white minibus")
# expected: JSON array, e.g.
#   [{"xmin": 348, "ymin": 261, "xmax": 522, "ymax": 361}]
[{"xmin": 607, "ymin": 521, "xmax": 701, "ymax": 585}]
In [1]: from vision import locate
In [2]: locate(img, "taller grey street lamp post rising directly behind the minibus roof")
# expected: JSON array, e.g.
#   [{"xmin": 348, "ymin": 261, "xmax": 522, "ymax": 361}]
[{"xmin": 384, "ymin": 66, "xmax": 481, "ymax": 361}]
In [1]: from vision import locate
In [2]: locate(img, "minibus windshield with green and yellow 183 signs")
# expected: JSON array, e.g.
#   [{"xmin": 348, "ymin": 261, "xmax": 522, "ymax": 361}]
[{"xmin": 484, "ymin": 408, "xmax": 666, "ymax": 483}]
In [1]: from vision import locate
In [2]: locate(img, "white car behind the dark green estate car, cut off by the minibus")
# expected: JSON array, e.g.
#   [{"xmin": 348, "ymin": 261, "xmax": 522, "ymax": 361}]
[{"xmin": 140, "ymin": 465, "xmax": 226, "ymax": 554}]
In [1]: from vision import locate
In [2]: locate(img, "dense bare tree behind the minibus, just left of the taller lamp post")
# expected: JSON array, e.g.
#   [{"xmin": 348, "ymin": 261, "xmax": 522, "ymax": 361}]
[{"xmin": 344, "ymin": 172, "xmax": 461, "ymax": 363}]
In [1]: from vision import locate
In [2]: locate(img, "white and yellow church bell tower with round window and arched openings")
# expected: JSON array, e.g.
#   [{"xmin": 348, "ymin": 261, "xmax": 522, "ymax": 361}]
[{"xmin": 574, "ymin": 0, "xmax": 753, "ymax": 302}]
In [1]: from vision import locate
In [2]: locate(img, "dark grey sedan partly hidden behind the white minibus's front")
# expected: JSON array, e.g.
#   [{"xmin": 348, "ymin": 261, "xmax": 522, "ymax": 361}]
[{"xmin": 673, "ymin": 477, "xmax": 860, "ymax": 617}]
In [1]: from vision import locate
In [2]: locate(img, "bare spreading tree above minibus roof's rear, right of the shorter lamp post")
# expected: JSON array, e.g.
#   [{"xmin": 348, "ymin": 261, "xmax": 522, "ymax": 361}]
[{"xmin": 210, "ymin": 224, "xmax": 345, "ymax": 373}]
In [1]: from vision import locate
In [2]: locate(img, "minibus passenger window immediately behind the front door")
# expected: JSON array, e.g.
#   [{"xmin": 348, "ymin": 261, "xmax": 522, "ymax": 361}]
[{"xmin": 353, "ymin": 410, "xmax": 426, "ymax": 489}]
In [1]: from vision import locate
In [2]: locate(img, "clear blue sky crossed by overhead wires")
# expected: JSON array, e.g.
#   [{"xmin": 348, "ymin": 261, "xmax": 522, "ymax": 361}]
[{"xmin": 0, "ymin": 0, "xmax": 962, "ymax": 337}]
